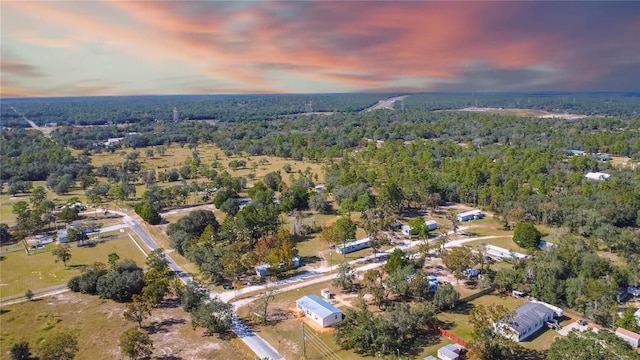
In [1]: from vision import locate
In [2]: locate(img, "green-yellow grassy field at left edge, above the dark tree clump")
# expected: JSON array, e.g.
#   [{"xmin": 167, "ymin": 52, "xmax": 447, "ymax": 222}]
[{"xmin": 0, "ymin": 232, "xmax": 145, "ymax": 297}]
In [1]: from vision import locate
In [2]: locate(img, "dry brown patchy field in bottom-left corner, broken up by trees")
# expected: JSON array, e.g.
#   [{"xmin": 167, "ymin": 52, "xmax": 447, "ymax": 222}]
[{"xmin": 0, "ymin": 292, "xmax": 254, "ymax": 360}]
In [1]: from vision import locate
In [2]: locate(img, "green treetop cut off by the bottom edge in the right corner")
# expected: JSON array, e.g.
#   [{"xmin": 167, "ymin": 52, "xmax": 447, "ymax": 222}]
[{"xmin": 547, "ymin": 329, "xmax": 638, "ymax": 360}]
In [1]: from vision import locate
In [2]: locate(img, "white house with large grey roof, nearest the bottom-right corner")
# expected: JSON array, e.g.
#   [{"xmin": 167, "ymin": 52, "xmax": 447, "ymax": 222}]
[{"xmin": 497, "ymin": 302, "xmax": 556, "ymax": 342}]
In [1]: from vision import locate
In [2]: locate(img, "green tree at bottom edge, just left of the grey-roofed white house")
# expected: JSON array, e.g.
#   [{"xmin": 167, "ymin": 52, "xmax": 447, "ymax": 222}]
[{"xmin": 467, "ymin": 304, "xmax": 517, "ymax": 360}]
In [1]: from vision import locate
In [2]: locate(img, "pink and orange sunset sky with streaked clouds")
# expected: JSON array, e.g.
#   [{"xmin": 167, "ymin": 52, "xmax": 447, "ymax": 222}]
[{"xmin": 0, "ymin": 0, "xmax": 640, "ymax": 98}]
